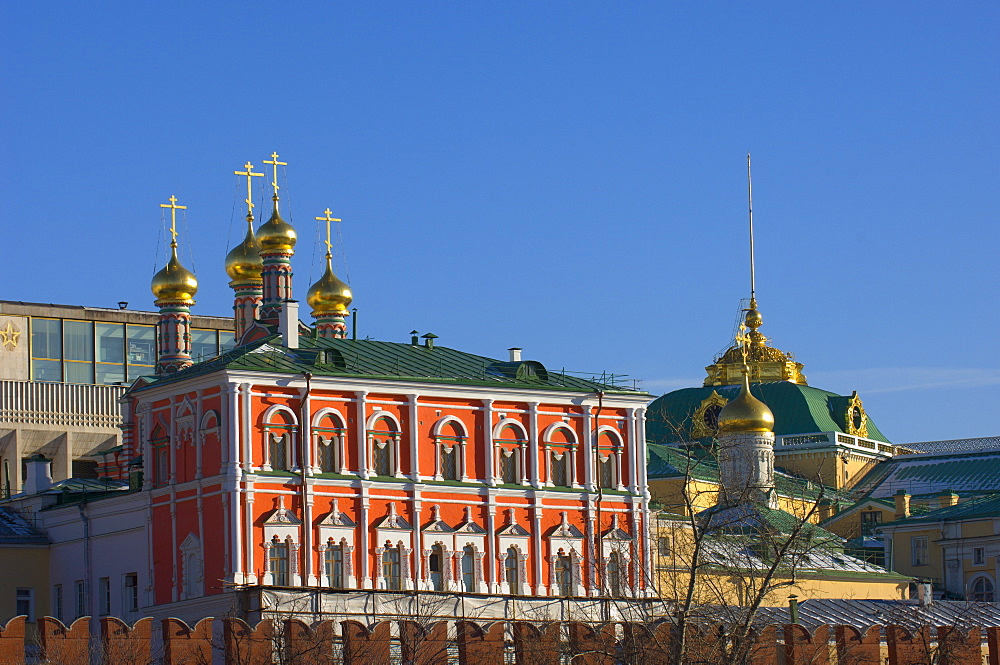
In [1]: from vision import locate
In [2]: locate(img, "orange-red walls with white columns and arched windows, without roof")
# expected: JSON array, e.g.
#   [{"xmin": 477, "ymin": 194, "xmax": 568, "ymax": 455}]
[{"xmin": 123, "ymin": 364, "xmax": 649, "ymax": 604}]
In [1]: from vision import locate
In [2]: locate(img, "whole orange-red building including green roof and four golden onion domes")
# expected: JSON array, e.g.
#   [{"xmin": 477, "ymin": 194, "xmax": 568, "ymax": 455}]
[{"xmin": 106, "ymin": 155, "xmax": 653, "ymax": 605}]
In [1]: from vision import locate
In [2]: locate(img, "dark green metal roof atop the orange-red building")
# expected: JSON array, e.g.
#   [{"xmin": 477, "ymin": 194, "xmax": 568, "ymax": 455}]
[{"xmin": 132, "ymin": 334, "xmax": 648, "ymax": 396}]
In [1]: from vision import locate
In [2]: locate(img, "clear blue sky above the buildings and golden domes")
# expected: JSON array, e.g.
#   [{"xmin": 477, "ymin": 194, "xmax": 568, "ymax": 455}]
[{"xmin": 0, "ymin": 2, "xmax": 1000, "ymax": 442}]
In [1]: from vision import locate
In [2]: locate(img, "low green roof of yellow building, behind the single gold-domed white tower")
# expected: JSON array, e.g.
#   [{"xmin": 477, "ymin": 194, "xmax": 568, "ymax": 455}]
[{"xmin": 646, "ymin": 444, "xmax": 853, "ymax": 503}]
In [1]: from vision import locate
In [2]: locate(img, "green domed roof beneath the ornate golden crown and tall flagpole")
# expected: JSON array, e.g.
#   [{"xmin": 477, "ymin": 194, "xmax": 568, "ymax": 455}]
[{"xmin": 646, "ymin": 381, "xmax": 890, "ymax": 443}]
